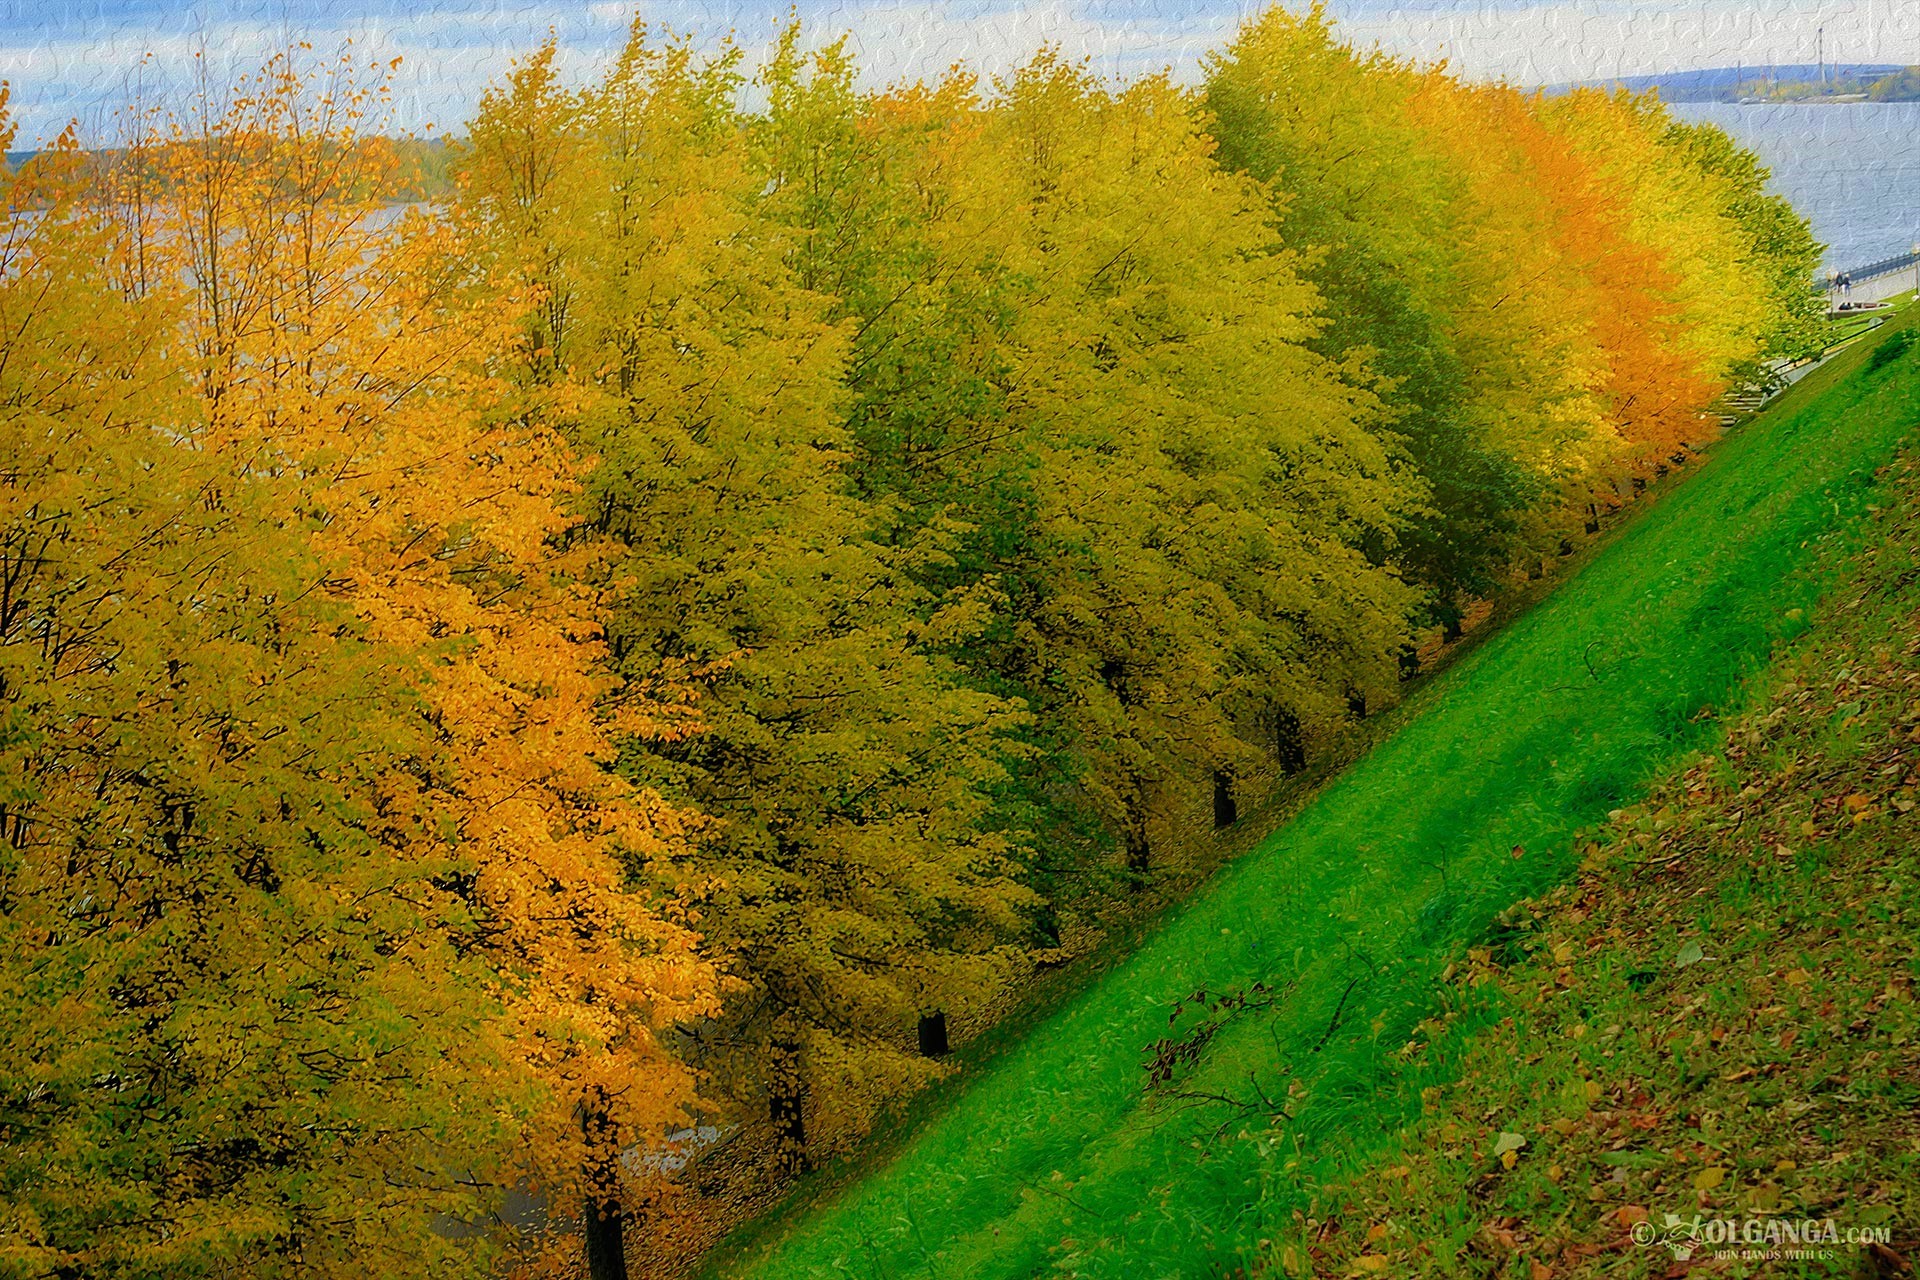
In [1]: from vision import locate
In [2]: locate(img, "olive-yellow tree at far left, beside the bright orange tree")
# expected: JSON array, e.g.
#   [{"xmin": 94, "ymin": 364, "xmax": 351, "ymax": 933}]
[{"xmin": 0, "ymin": 98, "xmax": 518, "ymax": 1278}]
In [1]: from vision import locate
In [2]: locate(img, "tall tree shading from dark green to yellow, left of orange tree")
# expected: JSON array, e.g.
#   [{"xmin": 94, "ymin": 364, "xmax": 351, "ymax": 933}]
[{"xmin": 1206, "ymin": 8, "xmax": 1597, "ymax": 631}]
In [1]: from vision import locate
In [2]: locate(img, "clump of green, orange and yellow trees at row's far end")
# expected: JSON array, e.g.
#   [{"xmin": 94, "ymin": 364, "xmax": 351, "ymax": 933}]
[{"xmin": 1206, "ymin": 6, "xmax": 1811, "ymax": 602}]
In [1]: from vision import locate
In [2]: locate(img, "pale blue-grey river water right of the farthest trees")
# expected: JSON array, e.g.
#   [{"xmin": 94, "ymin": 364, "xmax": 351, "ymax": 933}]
[{"xmin": 1667, "ymin": 102, "xmax": 1920, "ymax": 271}]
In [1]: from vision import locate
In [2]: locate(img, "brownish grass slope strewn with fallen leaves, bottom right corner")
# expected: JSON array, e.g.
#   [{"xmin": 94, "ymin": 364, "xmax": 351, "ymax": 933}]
[{"xmin": 1271, "ymin": 408, "xmax": 1920, "ymax": 1280}]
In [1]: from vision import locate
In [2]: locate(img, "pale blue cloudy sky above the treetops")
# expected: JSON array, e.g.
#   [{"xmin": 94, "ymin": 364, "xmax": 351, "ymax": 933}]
[{"xmin": 0, "ymin": 0, "xmax": 1920, "ymax": 146}]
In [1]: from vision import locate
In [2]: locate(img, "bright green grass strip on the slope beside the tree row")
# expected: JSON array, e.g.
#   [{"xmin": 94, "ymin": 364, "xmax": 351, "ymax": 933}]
[{"xmin": 714, "ymin": 322, "xmax": 1920, "ymax": 1280}]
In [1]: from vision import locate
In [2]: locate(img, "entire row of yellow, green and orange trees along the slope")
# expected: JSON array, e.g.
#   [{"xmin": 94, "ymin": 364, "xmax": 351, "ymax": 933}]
[{"xmin": 0, "ymin": 10, "xmax": 1818, "ymax": 1276}]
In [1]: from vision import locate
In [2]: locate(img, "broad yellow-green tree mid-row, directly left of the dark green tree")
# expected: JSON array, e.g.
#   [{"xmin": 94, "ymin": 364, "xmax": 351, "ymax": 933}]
[{"xmin": 748, "ymin": 46, "xmax": 1411, "ymax": 901}]
